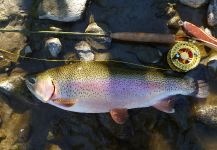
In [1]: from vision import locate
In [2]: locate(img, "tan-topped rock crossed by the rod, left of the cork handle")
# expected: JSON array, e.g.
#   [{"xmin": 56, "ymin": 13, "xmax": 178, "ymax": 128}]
[{"xmin": 85, "ymin": 22, "xmax": 111, "ymax": 50}]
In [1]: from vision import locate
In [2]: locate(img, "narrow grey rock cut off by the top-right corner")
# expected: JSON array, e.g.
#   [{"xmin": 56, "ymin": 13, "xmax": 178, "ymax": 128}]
[{"xmin": 207, "ymin": 0, "xmax": 217, "ymax": 26}]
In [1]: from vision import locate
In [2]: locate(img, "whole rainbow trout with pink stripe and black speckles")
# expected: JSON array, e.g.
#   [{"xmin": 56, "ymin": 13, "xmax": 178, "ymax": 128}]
[{"xmin": 26, "ymin": 62, "xmax": 208, "ymax": 124}]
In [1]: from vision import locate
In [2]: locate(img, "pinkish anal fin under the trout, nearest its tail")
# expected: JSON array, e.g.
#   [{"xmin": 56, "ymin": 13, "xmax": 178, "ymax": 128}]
[{"xmin": 153, "ymin": 99, "xmax": 175, "ymax": 113}]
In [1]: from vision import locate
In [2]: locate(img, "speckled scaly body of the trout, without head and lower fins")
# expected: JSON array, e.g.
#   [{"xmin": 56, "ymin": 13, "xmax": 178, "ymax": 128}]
[{"xmin": 26, "ymin": 62, "xmax": 200, "ymax": 113}]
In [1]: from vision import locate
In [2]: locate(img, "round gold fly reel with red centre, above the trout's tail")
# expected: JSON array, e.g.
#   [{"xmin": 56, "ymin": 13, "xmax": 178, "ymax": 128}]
[{"xmin": 167, "ymin": 41, "xmax": 201, "ymax": 72}]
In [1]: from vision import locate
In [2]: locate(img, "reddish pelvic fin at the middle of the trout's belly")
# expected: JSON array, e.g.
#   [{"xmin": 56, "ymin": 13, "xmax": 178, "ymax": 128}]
[{"xmin": 110, "ymin": 108, "xmax": 129, "ymax": 124}]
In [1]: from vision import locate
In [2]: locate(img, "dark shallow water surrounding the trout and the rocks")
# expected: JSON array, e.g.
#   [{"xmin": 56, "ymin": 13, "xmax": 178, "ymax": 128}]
[{"xmin": 0, "ymin": 0, "xmax": 217, "ymax": 150}]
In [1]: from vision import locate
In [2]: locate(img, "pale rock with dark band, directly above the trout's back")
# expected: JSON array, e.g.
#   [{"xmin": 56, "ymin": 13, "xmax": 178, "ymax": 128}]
[{"xmin": 75, "ymin": 41, "xmax": 94, "ymax": 61}]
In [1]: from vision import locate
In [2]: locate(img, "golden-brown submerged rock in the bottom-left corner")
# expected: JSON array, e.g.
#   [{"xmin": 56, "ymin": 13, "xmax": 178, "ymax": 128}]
[{"xmin": 0, "ymin": 99, "xmax": 30, "ymax": 150}]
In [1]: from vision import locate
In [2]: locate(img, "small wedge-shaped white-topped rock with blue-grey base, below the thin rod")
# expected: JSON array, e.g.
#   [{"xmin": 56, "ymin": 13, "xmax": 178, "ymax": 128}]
[{"xmin": 45, "ymin": 38, "xmax": 62, "ymax": 57}]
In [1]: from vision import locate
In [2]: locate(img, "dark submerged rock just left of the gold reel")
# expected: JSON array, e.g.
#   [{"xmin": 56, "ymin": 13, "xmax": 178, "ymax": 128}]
[{"xmin": 135, "ymin": 47, "xmax": 162, "ymax": 63}]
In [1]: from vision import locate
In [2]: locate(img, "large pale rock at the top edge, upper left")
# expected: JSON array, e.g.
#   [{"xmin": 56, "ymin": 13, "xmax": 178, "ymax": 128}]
[{"xmin": 38, "ymin": 0, "xmax": 87, "ymax": 22}]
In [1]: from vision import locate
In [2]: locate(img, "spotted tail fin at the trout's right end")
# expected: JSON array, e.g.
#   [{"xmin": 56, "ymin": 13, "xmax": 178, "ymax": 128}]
[{"xmin": 195, "ymin": 80, "xmax": 209, "ymax": 98}]
